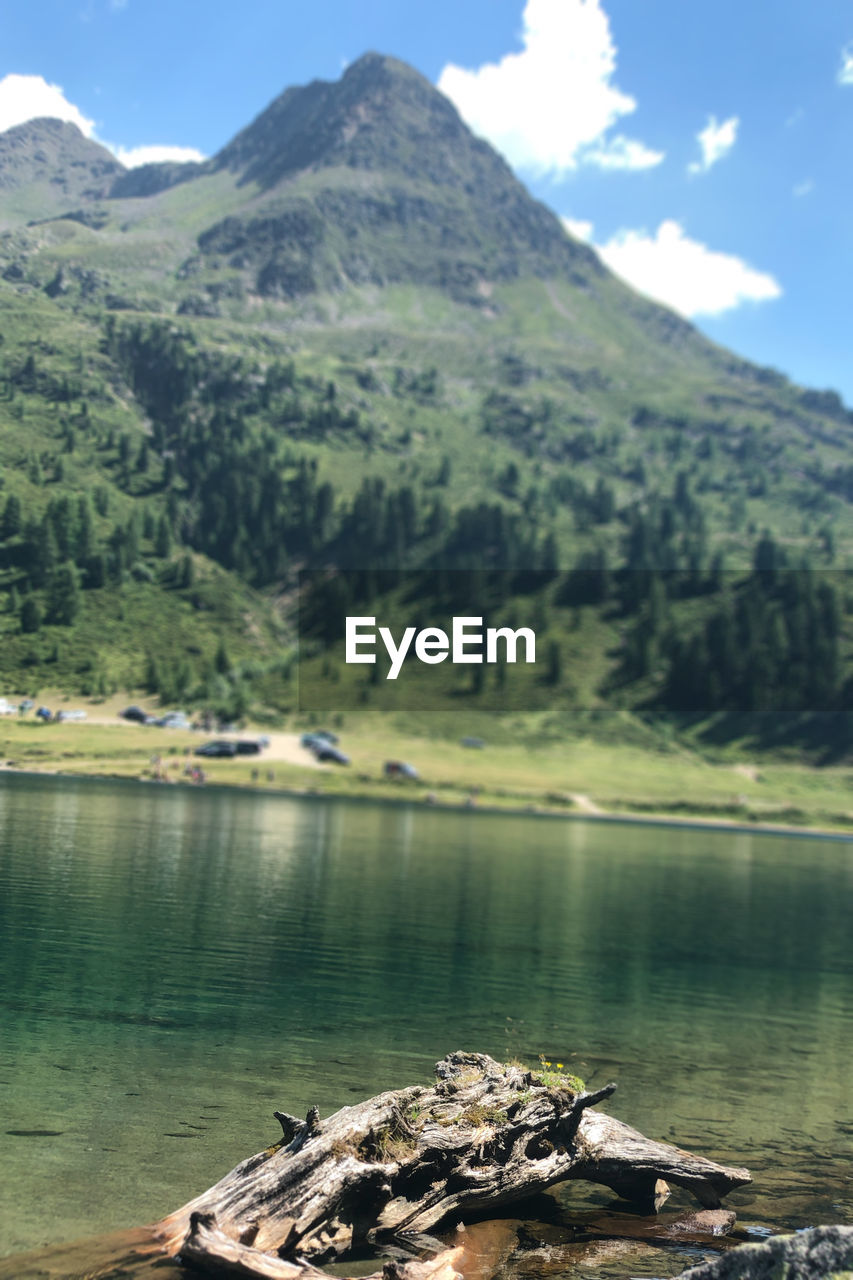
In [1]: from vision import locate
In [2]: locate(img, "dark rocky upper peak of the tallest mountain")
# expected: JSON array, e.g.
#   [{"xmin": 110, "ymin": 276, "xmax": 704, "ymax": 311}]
[{"xmin": 199, "ymin": 52, "xmax": 602, "ymax": 300}]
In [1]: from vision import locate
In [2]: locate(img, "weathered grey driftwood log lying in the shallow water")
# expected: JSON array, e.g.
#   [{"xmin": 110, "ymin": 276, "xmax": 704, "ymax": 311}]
[{"xmin": 154, "ymin": 1052, "xmax": 751, "ymax": 1280}]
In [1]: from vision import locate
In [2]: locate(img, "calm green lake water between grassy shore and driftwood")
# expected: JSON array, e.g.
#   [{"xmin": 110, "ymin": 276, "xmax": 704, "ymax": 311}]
[{"xmin": 0, "ymin": 774, "xmax": 853, "ymax": 1274}]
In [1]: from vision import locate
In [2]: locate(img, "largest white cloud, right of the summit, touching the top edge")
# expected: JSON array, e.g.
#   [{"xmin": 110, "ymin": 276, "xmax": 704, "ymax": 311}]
[{"xmin": 438, "ymin": 0, "xmax": 663, "ymax": 174}]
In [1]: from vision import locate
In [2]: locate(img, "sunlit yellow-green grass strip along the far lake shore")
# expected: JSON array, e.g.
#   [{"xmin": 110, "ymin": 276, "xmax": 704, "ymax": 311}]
[{"xmin": 0, "ymin": 698, "xmax": 853, "ymax": 831}]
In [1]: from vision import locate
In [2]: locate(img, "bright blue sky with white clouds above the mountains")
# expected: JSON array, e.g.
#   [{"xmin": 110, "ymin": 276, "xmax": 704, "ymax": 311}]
[{"xmin": 0, "ymin": 0, "xmax": 853, "ymax": 404}]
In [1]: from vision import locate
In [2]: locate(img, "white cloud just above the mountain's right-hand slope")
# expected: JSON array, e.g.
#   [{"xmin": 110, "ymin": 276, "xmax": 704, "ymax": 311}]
[{"xmin": 596, "ymin": 219, "xmax": 783, "ymax": 316}]
